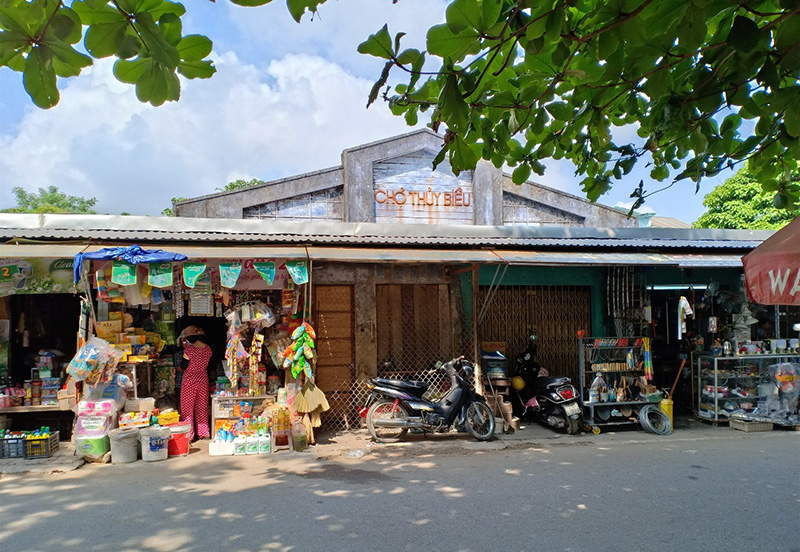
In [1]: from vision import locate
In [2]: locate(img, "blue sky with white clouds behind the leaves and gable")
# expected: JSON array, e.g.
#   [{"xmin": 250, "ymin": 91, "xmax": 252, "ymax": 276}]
[{"xmin": 0, "ymin": 0, "xmax": 730, "ymax": 222}]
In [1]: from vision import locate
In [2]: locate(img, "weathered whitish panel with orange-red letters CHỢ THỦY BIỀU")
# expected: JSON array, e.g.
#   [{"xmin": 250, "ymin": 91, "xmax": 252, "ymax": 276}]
[{"xmin": 373, "ymin": 169, "xmax": 475, "ymax": 224}]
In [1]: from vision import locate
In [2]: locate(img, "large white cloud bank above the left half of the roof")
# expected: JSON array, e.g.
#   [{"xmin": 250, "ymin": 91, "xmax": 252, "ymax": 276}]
[{"xmin": 0, "ymin": 53, "xmax": 422, "ymax": 214}]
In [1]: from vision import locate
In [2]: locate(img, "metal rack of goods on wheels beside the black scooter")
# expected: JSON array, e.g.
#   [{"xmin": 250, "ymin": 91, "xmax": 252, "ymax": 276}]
[{"xmin": 578, "ymin": 337, "xmax": 657, "ymax": 432}]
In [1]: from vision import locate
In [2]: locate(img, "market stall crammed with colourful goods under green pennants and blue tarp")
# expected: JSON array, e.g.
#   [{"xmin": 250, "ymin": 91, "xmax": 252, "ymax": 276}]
[{"xmin": 49, "ymin": 246, "xmax": 328, "ymax": 462}]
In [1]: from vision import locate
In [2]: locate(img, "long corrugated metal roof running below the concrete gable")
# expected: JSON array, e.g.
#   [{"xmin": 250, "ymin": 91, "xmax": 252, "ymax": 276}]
[{"xmin": 0, "ymin": 213, "xmax": 773, "ymax": 250}]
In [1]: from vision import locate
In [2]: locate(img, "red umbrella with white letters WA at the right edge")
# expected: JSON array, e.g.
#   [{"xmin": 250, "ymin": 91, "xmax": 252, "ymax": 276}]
[{"xmin": 742, "ymin": 217, "xmax": 800, "ymax": 305}]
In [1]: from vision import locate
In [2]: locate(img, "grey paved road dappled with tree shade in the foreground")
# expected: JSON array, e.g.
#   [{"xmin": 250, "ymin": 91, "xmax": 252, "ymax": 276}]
[{"xmin": 0, "ymin": 431, "xmax": 800, "ymax": 552}]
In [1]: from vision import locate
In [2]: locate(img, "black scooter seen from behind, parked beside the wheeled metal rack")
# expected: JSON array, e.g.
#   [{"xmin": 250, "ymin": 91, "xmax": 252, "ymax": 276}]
[{"xmin": 511, "ymin": 334, "xmax": 582, "ymax": 435}]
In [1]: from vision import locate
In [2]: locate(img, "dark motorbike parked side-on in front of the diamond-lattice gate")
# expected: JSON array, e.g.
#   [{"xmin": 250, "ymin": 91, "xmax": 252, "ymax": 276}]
[{"xmin": 360, "ymin": 357, "xmax": 495, "ymax": 443}]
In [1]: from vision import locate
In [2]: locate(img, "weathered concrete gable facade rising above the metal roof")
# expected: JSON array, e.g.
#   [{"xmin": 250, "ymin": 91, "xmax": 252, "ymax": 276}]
[{"xmin": 175, "ymin": 129, "xmax": 637, "ymax": 228}]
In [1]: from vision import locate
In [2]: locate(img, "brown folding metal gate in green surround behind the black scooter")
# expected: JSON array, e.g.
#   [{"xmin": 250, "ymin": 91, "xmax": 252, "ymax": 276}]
[{"xmin": 478, "ymin": 286, "xmax": 592, "ymax": 382}]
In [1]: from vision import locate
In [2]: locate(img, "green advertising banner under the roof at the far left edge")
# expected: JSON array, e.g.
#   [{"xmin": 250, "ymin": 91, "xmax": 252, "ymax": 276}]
[{"xmin": 0, "ymin": 258, "xmax": 75, "ymax": 297}]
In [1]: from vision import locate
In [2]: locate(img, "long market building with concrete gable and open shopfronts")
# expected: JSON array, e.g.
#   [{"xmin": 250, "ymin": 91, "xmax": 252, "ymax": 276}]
[{"xmin": 0, "ymin": 130, "xmax": 800, "ymax": 462}]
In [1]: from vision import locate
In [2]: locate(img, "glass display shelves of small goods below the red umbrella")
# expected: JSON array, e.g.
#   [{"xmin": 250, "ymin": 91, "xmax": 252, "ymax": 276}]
[{"xmin": 696, "ymin": 354, "xmax": 798, "ymax": 425}]
